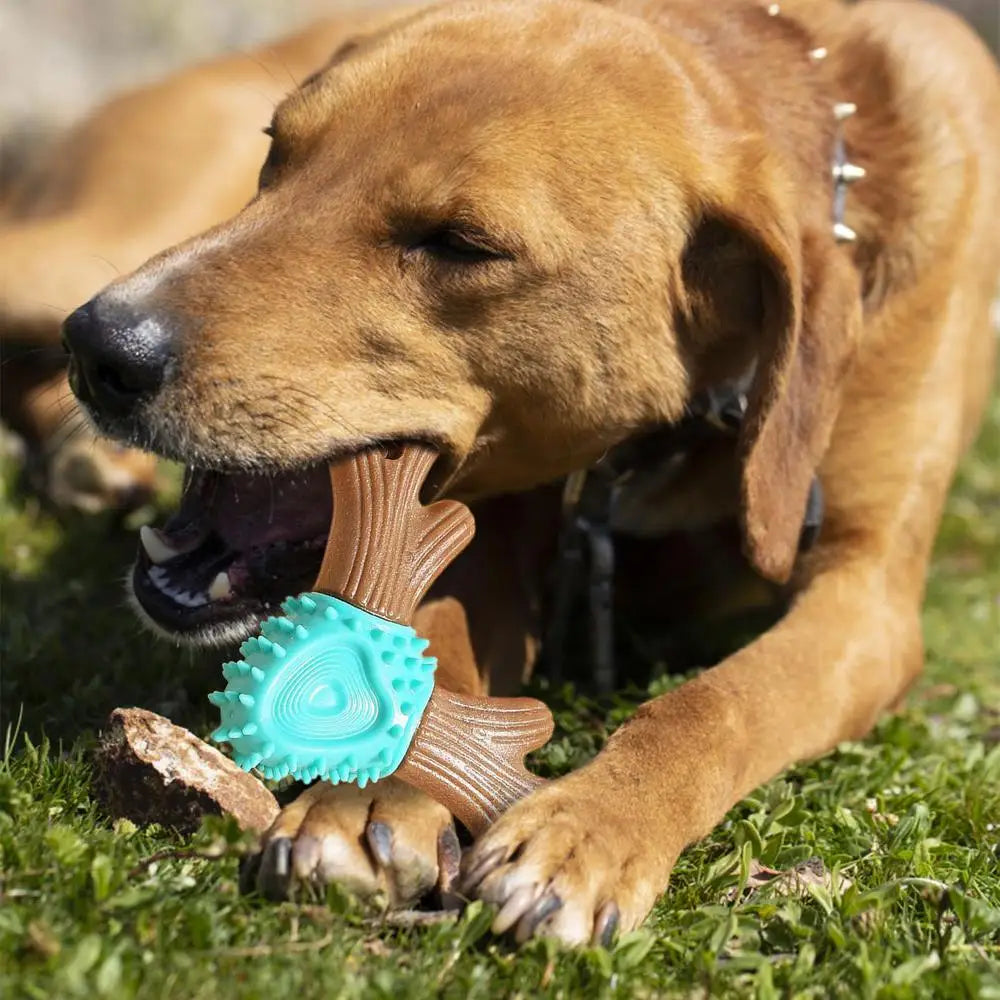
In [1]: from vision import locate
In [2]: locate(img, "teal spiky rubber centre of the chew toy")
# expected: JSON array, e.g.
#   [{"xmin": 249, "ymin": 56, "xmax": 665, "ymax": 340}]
[{"xmin": 208, "ymin": 593, "xmax": 437, "ymax": 788}]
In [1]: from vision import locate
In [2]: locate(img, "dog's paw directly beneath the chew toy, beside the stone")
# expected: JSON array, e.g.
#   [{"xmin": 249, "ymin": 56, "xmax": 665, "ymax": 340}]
[{"xmin": 240, "ymin": 778, "xmax": 461, "ymax": 907}]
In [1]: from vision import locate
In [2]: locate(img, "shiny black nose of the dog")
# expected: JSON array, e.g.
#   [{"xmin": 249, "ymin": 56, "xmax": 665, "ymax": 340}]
[{"xmin": 63, "ymin": 296, "xmax": 174, "ymax": 416}]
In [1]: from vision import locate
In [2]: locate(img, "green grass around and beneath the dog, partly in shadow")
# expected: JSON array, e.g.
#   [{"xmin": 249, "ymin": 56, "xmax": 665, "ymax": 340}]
[{"xmin": 0, "ymin": 386, "xmax": 1000, "ymax": 1000}]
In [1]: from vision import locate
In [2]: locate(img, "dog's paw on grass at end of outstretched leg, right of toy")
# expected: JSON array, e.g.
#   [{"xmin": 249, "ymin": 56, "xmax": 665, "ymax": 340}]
[{"xmin": 461, "ymin": 772, "xmax": 672, "ymax": 945}]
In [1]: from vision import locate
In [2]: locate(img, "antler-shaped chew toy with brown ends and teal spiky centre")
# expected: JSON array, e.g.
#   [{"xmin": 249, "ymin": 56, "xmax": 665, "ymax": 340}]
[{"xmin": 209, "ymin": 445, "xmax": 553, "ymax": 835}]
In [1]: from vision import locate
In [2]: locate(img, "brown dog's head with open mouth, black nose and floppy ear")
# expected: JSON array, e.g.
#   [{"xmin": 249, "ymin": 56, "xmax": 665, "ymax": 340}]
[{"xmin": 60, "ymin": 0, "xmax": 856, "ymax": 637}]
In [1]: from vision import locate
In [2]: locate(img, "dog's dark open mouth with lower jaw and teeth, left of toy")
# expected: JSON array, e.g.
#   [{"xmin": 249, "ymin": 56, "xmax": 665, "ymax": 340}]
[{"xmin": 132, "ymin": 465, "xmax": 332, "ymax": 640}]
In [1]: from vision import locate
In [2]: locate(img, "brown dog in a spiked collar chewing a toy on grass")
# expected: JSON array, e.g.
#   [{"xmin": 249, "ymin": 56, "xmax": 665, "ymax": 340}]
[{"xmin": 56, "ymin": 0, "xmax": 1000, "ymax": 942}]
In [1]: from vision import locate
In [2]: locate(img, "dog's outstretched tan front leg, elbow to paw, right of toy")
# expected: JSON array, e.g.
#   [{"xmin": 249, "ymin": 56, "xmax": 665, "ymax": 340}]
[{"xmin": 463, "ymin": 553, "xmax": 922, "ymax": 943}]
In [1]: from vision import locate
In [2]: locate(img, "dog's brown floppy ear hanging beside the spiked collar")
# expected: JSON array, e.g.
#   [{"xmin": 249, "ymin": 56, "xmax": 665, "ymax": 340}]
[{"xmin": 688, "ymin": 196, "xmax": 861, "ymax": 583}]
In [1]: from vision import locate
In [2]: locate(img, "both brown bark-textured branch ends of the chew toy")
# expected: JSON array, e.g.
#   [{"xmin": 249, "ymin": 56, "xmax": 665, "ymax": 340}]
[{"xmin": 315, "ymin": 445, "xmax": 553, "ymax": 836}]
